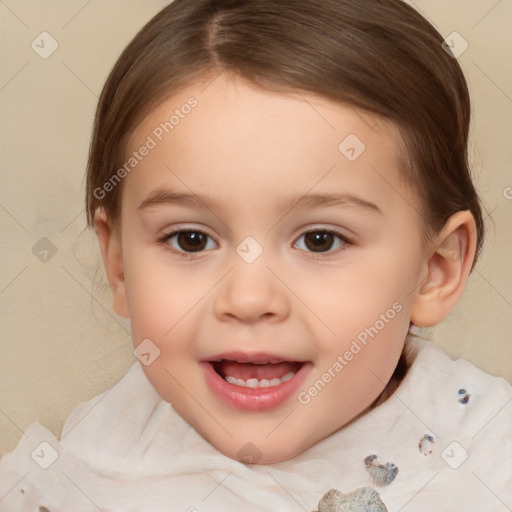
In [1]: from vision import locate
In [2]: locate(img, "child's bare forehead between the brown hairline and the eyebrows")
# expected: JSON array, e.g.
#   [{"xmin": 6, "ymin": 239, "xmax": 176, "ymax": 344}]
[{"xmin": 127, "ymin": 73, "xmax": 412, "ymax": 214}]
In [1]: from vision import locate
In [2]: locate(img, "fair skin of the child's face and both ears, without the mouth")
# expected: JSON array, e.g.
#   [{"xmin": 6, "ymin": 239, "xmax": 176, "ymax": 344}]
[{"xmin": 96, "ymin": 73, "xmax": 475, "ymax": 464}]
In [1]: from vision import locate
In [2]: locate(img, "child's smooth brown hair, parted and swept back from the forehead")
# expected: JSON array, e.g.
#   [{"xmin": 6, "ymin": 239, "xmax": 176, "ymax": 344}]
[{"xmin": 86, "ymin": 0, "xmax": 484, "ymax": 264}]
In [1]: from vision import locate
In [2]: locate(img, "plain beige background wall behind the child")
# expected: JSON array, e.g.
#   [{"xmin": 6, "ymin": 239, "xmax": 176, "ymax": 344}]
[{"xmin": 0, "ymin": 0, "xmax": 512, "ymax": 453}]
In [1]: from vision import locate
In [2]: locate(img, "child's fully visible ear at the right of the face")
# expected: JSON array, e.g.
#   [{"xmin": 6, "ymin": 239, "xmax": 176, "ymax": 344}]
[{"xmin": 410, "ymin": 210, "xmax": 476, "ymax": 327}]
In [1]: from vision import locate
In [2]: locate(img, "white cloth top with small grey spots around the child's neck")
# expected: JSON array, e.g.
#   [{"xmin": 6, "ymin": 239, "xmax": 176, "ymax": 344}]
[{"xmin": 0, "ymin": 335, "xmax": 512, "ymax": 512}]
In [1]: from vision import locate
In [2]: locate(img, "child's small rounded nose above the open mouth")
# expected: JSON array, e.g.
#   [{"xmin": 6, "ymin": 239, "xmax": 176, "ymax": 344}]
[{"xmin": 215, "ymin": 260, "xmax": 290, "ymax": 324}]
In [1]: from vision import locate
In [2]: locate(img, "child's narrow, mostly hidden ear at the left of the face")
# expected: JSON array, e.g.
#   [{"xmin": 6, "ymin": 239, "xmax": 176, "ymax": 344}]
[{"xmin": 94, "ymin": 208, "xmax": 130, "ymax": 318}]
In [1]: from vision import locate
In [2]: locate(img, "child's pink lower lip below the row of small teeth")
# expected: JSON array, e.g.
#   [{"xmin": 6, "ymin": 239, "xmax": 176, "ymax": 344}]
[{"xmin": 199, "ymin": 361, "xmax": 312, "ymax": 411}]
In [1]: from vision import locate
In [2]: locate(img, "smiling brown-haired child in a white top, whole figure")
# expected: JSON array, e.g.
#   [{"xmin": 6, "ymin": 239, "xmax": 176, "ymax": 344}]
[{"xmin": 0, "ymin": 0, "xmax": 512, "ymax": 512}]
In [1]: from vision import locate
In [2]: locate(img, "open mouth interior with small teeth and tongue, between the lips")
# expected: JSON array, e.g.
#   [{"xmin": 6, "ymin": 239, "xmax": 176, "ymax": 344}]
[{"xmin": 210, "ymin": 359, "xmax": 304, "ymax": 389}]
